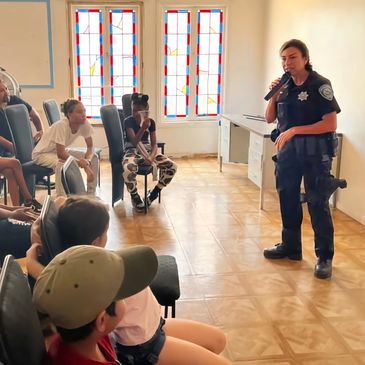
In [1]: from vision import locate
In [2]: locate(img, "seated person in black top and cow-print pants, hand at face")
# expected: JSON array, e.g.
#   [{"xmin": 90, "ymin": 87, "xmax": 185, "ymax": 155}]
[{"xmin": 123, "ymin": 93, "xmax": 177, "ymax": 210}]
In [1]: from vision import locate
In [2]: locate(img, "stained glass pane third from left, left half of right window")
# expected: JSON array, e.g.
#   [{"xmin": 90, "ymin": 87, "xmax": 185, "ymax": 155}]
[{"xmin": 164, "ymin": 10, "xmax": 190, "ymax": 118}]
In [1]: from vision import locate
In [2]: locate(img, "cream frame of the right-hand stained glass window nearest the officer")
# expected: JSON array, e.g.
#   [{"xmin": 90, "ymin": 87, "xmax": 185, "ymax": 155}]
[{"xmin": 158, "ymin": 4, "xmax": 227, "ymax": 125}]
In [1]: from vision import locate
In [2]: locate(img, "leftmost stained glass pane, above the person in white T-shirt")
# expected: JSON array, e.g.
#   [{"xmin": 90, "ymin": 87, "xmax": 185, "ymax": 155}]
[{"xmin": 75, "ymin": 9, "xmax": 104, "ymax": 117}]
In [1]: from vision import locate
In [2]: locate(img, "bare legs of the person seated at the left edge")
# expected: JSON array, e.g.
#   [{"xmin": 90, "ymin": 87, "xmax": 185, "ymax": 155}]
[{"xmin": 0, "ymin": 157, "xmax": 42, "ymax": 212}]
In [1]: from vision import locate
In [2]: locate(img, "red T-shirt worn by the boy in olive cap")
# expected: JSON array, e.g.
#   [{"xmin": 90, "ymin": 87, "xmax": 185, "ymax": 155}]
[{"xmin": 46, "ymin": 335, "xmax": 118, "ymax": 365}]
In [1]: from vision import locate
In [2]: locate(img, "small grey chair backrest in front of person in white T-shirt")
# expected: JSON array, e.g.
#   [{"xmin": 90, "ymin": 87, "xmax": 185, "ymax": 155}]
[{"xmin": 61, "ymin": 156, "xmax": 86, "ymax": 195}]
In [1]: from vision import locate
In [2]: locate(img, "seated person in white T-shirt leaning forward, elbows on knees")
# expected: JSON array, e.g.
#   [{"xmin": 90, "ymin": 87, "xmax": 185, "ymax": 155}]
[{"xmin": 32, "ymin": 99, "xmax": 99, "ymax": 196}]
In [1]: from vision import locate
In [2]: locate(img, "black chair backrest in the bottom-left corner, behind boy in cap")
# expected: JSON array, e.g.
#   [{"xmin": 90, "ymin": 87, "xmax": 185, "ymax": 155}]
[{"xmin": 0, "ymin": 255, "xmax": 46, "ymax": 365}]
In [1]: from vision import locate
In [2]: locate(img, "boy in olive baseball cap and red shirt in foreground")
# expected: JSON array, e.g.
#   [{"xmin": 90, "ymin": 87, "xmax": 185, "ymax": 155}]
[{"xmin": 33, "ymin": 245, "xmax": 158, "ymax": 365}]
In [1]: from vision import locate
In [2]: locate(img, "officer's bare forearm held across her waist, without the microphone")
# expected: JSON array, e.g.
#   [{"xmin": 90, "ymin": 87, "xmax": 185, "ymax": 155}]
[{"xmin": 275, "ymin": 112, "xmax": 337, "ymax": 151}]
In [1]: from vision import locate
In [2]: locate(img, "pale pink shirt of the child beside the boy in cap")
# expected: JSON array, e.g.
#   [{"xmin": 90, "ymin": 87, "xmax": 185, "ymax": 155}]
[{"xmin": 113, "ymin": 287, "xmax": 161, "ymax": 346}]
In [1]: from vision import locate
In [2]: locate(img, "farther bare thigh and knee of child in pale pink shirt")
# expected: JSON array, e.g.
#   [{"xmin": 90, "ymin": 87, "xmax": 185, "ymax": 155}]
[{"xmin": 163, "ymin": 318, "xmax": 226, "ymax": 354}]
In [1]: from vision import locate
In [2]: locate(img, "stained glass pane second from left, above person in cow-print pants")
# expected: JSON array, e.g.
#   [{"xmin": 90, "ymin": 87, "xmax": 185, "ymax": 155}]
[{"xmin": 109, "ymin": 9, "xmax": 137, "ymax": 106}]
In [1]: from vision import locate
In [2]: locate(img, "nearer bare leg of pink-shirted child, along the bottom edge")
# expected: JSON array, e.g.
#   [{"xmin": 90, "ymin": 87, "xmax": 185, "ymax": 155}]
[{"xmin": 157, "ymin": 336, "xmax": 232, "ymax": 365}]
